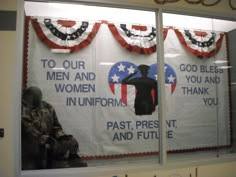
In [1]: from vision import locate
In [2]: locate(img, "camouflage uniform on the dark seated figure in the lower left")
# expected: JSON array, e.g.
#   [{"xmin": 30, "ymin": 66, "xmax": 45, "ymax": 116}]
[{"xmin": 22, "ymin": 101, "xmax": 84, "ymax": 169}]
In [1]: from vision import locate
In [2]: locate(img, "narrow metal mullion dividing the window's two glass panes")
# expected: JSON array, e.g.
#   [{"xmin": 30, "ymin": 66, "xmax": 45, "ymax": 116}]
[{"xmin": 156, "ymin": 9, "xmax": 167, "ymax": 165}]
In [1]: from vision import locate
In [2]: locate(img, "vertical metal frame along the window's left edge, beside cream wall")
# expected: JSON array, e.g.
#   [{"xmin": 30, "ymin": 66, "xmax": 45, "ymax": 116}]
[{"xmin": 15, "ymin": 0, "xmax": 25, "ymax": 177}]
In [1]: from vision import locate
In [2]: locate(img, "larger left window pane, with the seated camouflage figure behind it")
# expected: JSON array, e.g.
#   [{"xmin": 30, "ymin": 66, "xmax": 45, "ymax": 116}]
[{"xmin": 22, "ymin": 2, "xmax": 159, "ymax": 170}]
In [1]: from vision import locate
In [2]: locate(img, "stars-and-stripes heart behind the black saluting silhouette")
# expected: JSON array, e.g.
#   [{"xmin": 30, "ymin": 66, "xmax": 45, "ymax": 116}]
[{"xmin": 108, "ymin": 61, "xmax": 177, "ymax": 107}]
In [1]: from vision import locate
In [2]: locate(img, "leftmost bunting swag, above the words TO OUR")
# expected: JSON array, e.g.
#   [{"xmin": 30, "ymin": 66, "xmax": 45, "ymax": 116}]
[{"xmin": 32, "ymin": 18, "xmax": 100, "ymax": 52}]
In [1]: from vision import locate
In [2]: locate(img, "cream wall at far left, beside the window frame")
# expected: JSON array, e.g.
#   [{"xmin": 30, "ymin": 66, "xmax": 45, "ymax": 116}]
[{"xmin": 0, "ymin": 0, "xmax": 16, "ymax": 177}]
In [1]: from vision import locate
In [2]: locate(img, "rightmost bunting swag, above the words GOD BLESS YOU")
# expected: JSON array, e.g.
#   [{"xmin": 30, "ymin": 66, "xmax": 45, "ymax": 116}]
[{"xmin": 174, "ymin": 29, "xmax": 224, "ymax": 58}]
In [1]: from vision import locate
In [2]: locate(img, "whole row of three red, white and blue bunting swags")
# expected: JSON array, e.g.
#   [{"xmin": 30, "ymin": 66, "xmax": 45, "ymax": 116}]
[{"xmin": 31, "ymin": 18, "xmax": 224, "ymax": 58}]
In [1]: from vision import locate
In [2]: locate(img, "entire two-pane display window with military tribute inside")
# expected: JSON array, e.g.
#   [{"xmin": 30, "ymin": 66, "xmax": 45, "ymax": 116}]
[{"xmin": 21, "ymin": 1, "xmax": 236, "ymax": 174}]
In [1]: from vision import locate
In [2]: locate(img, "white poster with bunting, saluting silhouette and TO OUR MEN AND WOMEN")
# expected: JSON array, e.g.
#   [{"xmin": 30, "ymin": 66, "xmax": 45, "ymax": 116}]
[{"xmin": 24, "ymin": 17, "xmax": 231, "ymax": 159}]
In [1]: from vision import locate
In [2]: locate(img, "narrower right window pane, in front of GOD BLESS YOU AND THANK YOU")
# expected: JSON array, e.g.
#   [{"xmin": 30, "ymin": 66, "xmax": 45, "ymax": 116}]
[{"xmin": 163, "ymin": 14, "xmax": 236, "ymax": 160}]
